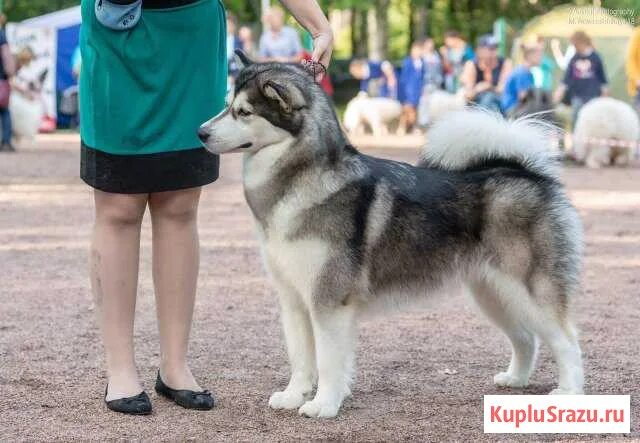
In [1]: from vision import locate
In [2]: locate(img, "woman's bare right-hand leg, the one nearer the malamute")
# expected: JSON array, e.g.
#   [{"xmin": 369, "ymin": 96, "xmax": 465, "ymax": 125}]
[{"xmin": 149, "ymin": 188, "xmax": 201, "ymax": 391}]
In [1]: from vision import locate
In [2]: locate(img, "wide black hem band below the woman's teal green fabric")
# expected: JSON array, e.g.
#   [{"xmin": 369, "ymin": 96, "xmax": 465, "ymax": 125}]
[{"xmin": 80, "ymin": 143, "xmax": 220, "ymax": 194}]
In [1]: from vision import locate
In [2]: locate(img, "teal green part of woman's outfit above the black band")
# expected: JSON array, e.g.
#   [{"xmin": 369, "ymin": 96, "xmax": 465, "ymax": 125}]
[{"xmin": 80, "ymin": 0, "xmax": 227, "ymax": 155}]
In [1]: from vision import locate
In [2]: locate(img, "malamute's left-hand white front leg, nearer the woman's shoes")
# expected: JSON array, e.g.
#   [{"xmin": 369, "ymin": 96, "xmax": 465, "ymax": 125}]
[{"xmin": 269, "ymin": 285, "xmax": 316, "ymax": 409}]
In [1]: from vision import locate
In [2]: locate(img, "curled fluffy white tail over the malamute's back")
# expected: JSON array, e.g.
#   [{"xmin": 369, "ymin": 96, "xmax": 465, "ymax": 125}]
[{"xmin": 420, "ymin": 109, "xmax": 559, "ymax": 177}]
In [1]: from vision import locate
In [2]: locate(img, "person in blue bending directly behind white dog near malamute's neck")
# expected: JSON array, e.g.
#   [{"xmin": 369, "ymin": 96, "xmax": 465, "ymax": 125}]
[{"xmin": 349, "ymin": 59, "xmax": 398, "ymax": 99}]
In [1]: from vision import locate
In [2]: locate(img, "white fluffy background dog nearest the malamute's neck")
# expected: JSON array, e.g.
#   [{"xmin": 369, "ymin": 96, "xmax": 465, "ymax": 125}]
[{"xmin": 343, "ymin": 92, "xmax": 402, "ymax": 136}]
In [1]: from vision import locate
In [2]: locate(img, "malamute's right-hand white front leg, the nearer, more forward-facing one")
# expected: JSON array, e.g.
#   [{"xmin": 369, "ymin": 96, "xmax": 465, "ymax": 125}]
[{"xmin": 298, "ymin": 305, "xmax": 357, "ymax": 418}]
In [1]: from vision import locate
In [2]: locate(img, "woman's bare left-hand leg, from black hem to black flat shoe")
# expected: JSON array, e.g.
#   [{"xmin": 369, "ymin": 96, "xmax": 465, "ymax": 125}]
[{"xmin": 90, "ymin": 190, "xmax": 147, "ymax": 400}]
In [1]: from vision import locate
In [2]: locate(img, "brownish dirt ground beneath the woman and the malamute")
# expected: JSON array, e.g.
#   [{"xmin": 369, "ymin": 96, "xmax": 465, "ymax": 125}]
[{"xmin": 0, "ymin": 135, "xmax": 640, "ymax": 441}]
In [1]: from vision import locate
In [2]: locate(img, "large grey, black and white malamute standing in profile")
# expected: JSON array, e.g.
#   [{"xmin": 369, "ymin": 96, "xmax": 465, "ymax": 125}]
[{"xmin": 199, "ymin": 53, "xmax": 583, "ymax": 417}]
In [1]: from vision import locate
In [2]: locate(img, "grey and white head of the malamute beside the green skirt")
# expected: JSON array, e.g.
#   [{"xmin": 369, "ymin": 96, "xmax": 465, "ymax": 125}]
[{"xmin": 198, "ymin": 51, "xmax": 327, "ymax": 154}]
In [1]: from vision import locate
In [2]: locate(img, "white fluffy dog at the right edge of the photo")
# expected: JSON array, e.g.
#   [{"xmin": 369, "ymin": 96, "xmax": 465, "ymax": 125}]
[{"xmin": 573, "ymin": 97, "xmax": 640, "ymax": 168}]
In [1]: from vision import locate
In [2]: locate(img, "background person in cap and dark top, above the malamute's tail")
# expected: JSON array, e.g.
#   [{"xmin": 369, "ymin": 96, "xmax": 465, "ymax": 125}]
[{"xmin": 461, "ymin": 34, "xmax": 511, "ymax": 112}]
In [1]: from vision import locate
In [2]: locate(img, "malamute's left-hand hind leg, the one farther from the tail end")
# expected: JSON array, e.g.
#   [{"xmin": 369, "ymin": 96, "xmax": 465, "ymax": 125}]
[{"xmin": 470, "ymin": 278, "xmax": 538, "ymax": 388}]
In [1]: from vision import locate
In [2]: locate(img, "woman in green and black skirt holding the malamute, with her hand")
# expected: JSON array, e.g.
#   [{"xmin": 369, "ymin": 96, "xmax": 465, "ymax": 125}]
[{"xmin": 80, "ymin": 0, "xmax": 332, "ymax": 414}]
